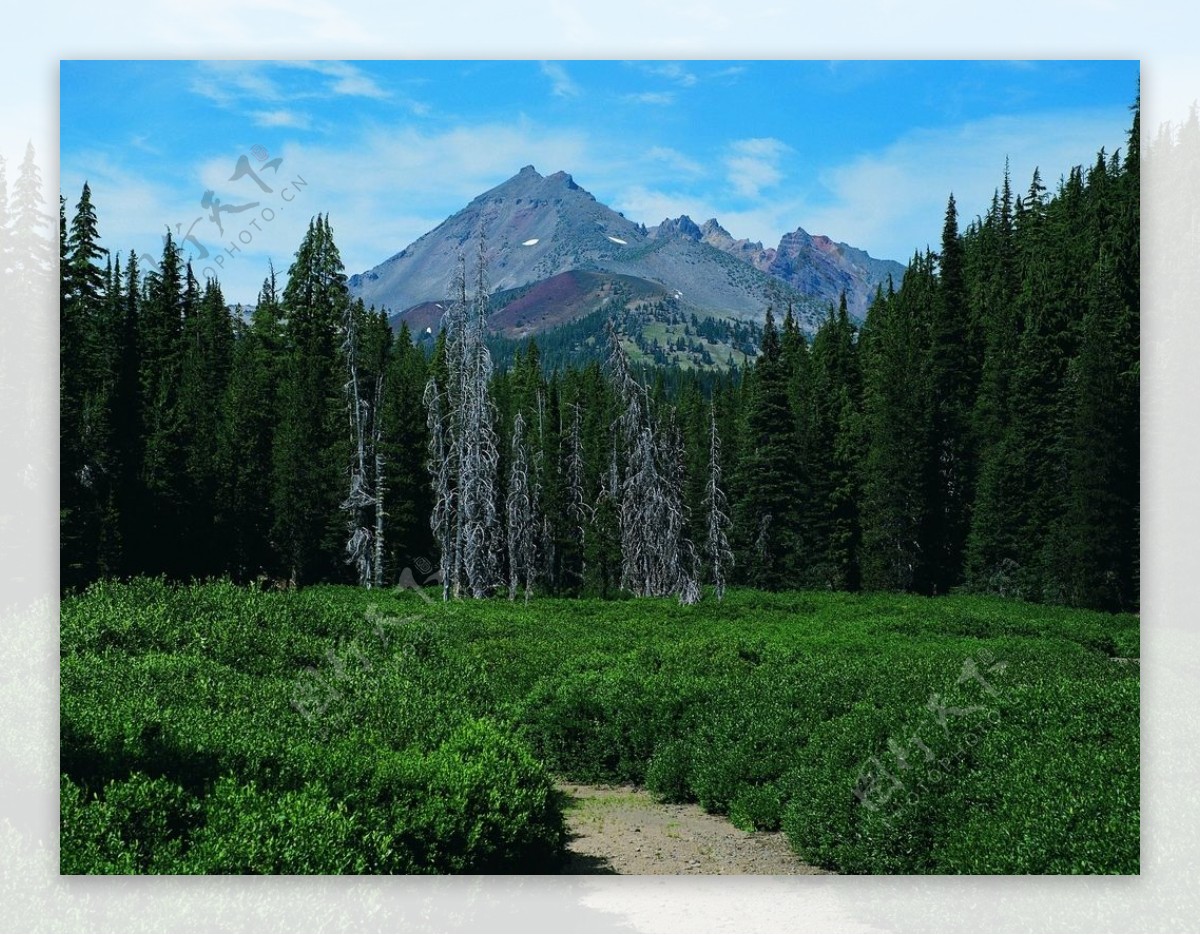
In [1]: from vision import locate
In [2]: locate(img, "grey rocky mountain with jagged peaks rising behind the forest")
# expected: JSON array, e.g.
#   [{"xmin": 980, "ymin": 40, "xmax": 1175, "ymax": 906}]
[{"xmin": 349, "ymin": 166, "xmax": 902, "ymax": 337}]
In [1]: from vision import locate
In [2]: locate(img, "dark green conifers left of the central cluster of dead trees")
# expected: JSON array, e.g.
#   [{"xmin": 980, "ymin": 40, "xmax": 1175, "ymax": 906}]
[{"xmin": 60, "ymin": 204, "xmax": 432, "ymax": 588}]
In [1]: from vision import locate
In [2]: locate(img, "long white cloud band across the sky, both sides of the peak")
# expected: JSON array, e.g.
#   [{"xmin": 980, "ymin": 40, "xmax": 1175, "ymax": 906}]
[{"xmin": 62, "ymin": 96, "xmax": 1128, "ymax": 300}]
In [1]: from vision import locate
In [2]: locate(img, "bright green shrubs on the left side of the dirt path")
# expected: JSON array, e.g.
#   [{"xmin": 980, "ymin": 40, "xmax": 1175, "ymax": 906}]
[{"xmin": 61, "ymin": 580, "xmax": 564, "ymax": 874}]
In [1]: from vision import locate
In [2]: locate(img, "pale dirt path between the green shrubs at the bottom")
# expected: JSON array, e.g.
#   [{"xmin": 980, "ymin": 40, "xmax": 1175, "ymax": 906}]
[{"xmin": 558, "ymin": 783, "xmax": 826, "ymax": 874}]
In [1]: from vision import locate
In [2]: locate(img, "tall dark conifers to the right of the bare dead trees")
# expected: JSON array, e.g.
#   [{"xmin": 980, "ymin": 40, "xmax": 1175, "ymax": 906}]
[{"xmin": 758, "ymin": 102, "xmax": 1139, "ymax": 610}]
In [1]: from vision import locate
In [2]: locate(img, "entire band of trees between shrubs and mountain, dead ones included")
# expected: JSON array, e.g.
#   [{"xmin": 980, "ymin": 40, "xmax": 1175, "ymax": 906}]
[{"xmin": 61, "ymin": 100, "xmax": 1139, "ymax": 609}]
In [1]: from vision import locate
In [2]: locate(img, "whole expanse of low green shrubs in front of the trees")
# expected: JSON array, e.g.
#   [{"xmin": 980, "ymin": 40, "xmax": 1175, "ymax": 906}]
[{"xmin": 61, "ymin": 580, "xmax": 1139, "ymax": 873}]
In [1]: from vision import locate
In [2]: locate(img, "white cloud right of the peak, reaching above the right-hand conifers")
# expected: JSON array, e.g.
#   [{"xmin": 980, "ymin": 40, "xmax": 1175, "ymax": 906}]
[{"xmin": 610, "ymin": 109, "xmax": 1128, "ymax": 262}]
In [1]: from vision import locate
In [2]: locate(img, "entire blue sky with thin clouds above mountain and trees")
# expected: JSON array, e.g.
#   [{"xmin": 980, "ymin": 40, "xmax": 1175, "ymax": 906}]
[{"xmin": 60, "ymin": 61, "xmax": 1138, "ymax": 301}]
